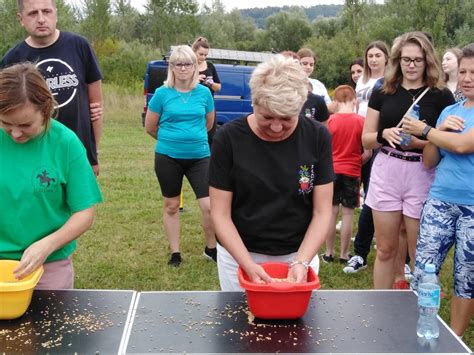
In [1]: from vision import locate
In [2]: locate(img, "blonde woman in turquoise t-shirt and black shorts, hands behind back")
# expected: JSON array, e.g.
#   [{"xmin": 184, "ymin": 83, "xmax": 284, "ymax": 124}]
[{"xmin": 145, "ymin": 46, "xmax": 217, "ymax": 267}]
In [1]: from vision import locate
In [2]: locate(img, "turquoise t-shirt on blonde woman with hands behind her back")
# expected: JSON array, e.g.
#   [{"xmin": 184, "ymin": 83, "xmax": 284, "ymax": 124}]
[{"xmin": 148, "ymin": 85, "xmax": 214, "ymax": 159}]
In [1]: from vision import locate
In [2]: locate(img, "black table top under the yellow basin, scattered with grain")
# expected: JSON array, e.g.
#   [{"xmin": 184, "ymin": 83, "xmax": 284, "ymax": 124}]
[{"xmin": 0, "ymin": 290, "xmax": 136, "ymax": 354}]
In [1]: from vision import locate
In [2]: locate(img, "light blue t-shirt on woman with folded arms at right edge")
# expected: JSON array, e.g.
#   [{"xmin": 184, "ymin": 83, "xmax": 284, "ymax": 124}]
[{"xmin": 429, "ymin": 101, "xmax": 474, "ymax": 206}]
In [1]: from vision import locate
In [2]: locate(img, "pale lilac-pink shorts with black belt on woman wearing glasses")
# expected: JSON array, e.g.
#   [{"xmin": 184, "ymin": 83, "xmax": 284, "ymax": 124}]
[{"xmin": 365, "ymin": 147, "xmax": 434, "ymax": 219}]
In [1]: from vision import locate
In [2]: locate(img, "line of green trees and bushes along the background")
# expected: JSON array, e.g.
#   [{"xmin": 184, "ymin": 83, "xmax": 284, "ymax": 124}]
[{"xmin": 0, "ymin": 0, "xmax": 474, "ymax": 87}]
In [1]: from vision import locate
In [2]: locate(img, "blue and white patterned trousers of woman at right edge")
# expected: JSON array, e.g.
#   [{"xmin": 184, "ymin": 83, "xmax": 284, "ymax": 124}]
[{"xmin": 412, "ymin": 199, "xmax": 474, "ymax": 299}]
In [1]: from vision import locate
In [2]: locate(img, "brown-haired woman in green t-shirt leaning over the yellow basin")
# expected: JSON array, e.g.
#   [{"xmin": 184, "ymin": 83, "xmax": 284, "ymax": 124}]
[{"xmin": 0, "ymin": 63, "xmax": 102, "ymax": 289}]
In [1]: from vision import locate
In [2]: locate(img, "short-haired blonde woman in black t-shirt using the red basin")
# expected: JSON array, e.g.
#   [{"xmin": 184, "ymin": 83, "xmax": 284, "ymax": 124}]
[{"xmin": 209, "ymin": 55, "xmax": 334, "ymax": 291}]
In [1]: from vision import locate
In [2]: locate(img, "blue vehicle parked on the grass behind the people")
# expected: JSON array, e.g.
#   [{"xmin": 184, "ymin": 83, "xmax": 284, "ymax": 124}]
[{"xmin": 142, "ymin": 49, "xmax": 272, "ymax": 125}]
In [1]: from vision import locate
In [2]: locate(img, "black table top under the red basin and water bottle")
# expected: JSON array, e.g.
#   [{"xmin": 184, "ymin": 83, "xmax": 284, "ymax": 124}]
[{"xmin": 126, "ymin": 290, "xmax": 469, "ymax": 353}]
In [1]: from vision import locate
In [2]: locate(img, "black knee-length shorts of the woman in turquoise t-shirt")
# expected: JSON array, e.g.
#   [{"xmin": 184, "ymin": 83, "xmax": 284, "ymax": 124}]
[{"xmin": 155, "ymin": 153, "xmax": 209, "ymax": 199}]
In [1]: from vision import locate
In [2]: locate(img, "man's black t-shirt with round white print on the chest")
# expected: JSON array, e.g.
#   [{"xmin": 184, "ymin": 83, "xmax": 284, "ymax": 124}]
[{"xmin": 0, "ymin": 32, "xmax": 102, "ymax": 165}]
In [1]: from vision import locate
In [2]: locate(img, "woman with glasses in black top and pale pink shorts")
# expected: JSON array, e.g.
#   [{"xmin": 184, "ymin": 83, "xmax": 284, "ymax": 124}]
[{"xmin": 362, "ymin": 32, "xmax": 454, "ymax": 289}]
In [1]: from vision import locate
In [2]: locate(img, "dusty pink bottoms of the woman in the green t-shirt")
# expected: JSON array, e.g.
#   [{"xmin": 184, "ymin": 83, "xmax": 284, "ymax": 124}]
[{"xmin": 35, "ymin": 256, "xmax": 74, "ymax": 290}]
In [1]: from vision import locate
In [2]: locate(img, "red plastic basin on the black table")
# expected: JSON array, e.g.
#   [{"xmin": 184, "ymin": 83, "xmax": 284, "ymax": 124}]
[{"xmin": 238, "ymin": 263, "xmax": 320, "ymax": 319}]
